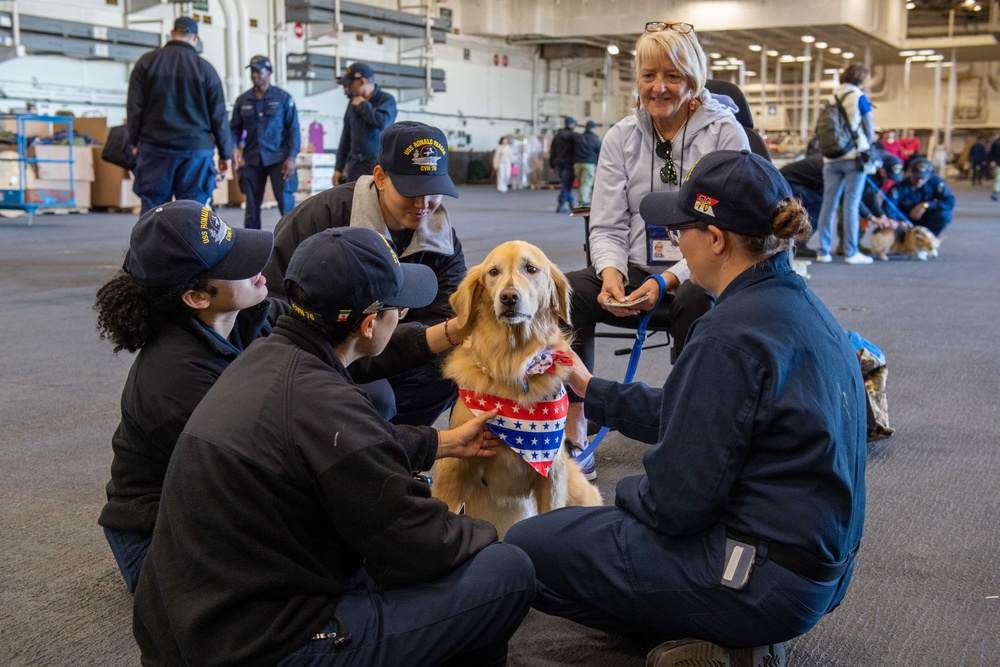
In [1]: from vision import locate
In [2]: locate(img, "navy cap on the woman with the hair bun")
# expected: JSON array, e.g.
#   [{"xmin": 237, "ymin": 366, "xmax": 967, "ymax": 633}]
[{"xmin": 639, "ymin": 150, "xmax": 792, "ymax": 236}]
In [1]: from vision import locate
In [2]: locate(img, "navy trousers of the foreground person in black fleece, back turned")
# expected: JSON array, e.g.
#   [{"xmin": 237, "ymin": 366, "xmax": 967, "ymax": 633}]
[{"xmin": 278, "ymin": 542, "xmax": 535, "ymax": 667}]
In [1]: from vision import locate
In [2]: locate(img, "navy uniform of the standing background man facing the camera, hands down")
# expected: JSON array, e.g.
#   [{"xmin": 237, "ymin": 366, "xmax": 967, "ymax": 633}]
[{"xmin": 229, "ymin": 86, "xmax": 301, "ymax": 229}]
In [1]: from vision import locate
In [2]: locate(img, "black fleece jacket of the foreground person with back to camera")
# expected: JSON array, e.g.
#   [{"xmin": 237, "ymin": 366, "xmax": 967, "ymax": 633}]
[{"xmin": 133, "ymin": 315, "xmax": 497, "ymax": 666}]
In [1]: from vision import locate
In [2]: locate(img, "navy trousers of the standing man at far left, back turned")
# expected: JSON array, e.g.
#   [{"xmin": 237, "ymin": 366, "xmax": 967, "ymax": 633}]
[{"xmin": 132, "ymin": 144, "xmax": 215, "ymax": 213}]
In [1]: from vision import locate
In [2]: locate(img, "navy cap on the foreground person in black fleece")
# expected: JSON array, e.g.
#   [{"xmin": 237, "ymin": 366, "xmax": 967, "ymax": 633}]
[{"xmin": 285, "ymin": 227, "xmax": 437, "ymax": 324}]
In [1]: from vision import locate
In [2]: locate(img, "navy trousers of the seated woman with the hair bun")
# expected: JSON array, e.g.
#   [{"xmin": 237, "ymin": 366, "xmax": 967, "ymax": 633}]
[{"xmin": 504, "ymin": 507, "xmax": 853, "ymax": 647}]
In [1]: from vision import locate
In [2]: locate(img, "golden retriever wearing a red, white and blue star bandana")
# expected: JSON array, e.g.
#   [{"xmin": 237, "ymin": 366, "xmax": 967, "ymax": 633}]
[{"xmin": 431, "ymin": 241, "xmax": 602, "ymax": 538}]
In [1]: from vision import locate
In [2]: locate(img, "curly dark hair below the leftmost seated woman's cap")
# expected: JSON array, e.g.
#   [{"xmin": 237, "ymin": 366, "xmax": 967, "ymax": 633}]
[{"xmin": 94, "ymin": 270, "xmax": 218, "ymax": 354}]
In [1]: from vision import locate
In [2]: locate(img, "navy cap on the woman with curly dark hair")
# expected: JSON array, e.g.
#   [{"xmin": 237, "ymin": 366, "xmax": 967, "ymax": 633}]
[{"xmin": 124, "ymin": 199, "xmax": 274, "ymax": 287}]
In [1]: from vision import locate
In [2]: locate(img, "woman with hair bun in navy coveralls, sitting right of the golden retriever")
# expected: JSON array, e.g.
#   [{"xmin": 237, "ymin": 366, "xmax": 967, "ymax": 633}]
[{"xmin": 504, "ymin": 150, "xmax": 866, "ymax": 667}]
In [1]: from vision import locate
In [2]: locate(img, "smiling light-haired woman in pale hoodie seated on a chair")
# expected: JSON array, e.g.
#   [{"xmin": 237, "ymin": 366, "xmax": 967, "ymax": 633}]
[{"xmin": 566, "ymin": 21, "xmax": 750, "ymax": 470}]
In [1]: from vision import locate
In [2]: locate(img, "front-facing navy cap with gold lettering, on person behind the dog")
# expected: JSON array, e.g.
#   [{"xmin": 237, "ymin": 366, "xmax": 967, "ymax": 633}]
[{"xmin": 378, "ymin": 120, "xmax": 458, "ymax": 197}]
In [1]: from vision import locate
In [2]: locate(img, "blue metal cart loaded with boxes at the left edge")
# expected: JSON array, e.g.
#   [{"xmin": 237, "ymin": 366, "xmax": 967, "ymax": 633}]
[{"xmin": 0, "ymin": 114, "xmax": 76, "ymax": 225}]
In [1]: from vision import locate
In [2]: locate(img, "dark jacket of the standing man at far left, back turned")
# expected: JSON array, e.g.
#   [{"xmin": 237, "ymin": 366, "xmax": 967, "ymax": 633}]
[{"xmin": 128, "ymin": 40, "xmax": 233, "ymax": 154}]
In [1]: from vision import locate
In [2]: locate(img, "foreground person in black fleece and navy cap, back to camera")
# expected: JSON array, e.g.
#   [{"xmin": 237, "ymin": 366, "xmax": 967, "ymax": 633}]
[{"xmin": 133, "ymin": 227, "xmax": 536, "ymax": 665}]
